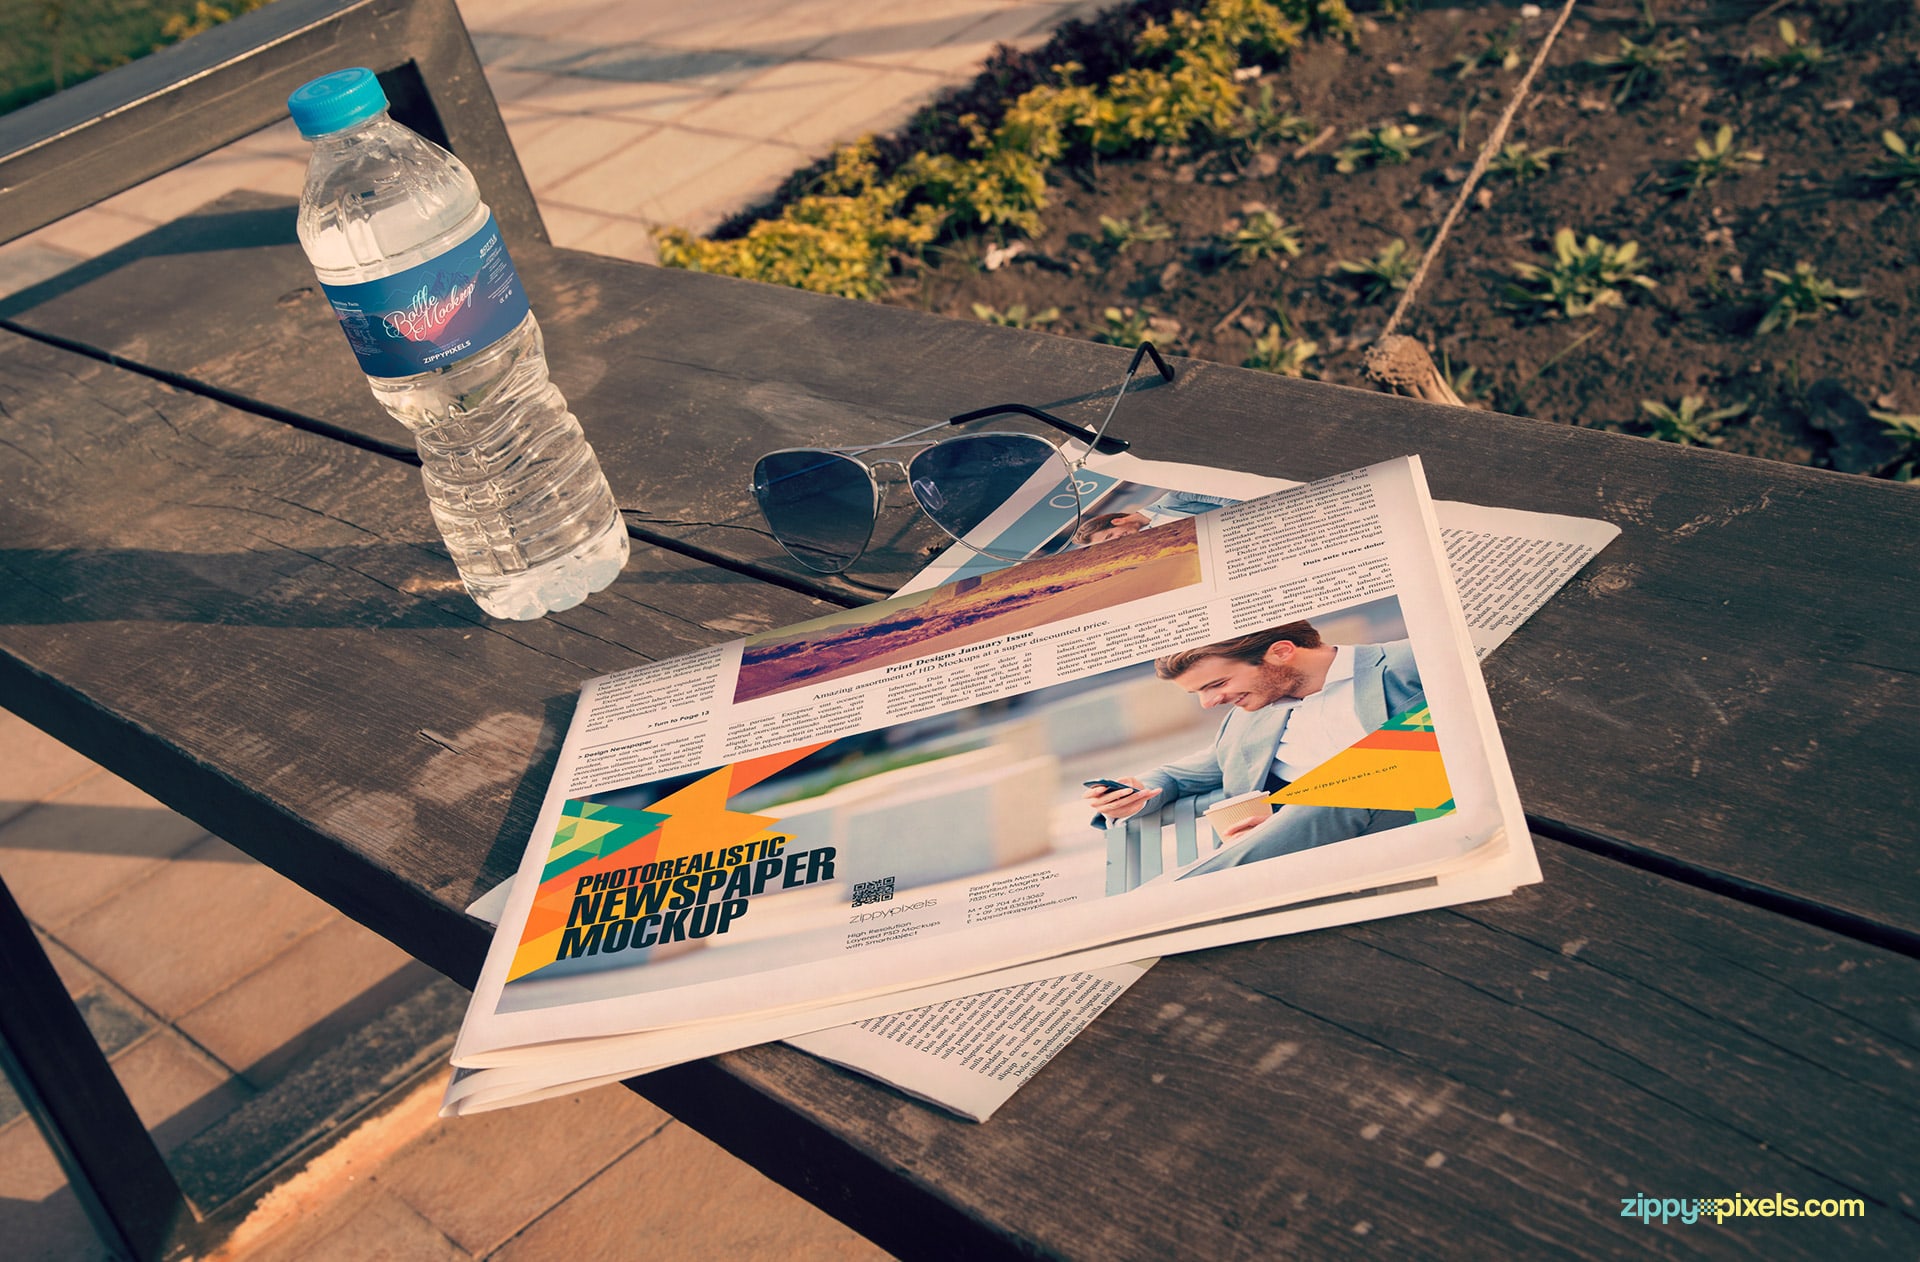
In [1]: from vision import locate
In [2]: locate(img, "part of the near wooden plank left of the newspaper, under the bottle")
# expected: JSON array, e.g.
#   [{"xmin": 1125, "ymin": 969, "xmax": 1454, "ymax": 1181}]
[{"xmin": 0, "ymin": 326, "xmax": 828, "ymax": 976}]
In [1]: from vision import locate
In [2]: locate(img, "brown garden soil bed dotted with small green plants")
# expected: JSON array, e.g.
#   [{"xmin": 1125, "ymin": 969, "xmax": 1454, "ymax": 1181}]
[{"xmin": 756, "ymin": 0, "xmax": 1920, "ymax": 476}]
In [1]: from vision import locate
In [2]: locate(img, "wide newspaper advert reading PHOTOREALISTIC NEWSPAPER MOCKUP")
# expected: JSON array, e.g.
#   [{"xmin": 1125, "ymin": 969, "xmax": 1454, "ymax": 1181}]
[{"xmin": 499, "ymin": 597, "xmax": 1453, "ymax": 1012}]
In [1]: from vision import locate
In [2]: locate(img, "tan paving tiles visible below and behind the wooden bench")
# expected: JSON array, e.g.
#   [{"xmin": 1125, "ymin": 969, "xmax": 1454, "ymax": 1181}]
[{"xmin": 0, "ymin": 0, "xmax": 1102, "ymax": 1262}]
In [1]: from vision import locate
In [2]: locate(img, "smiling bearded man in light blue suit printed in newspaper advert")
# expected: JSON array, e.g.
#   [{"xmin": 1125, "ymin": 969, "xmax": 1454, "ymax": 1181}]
[{"xmin": 1087, "ymin": 622, "xmax": 1425, "ymax": 876}]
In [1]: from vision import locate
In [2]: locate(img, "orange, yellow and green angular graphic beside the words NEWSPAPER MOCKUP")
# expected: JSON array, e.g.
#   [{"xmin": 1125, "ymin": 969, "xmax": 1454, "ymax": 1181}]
[{"xmin": 507, "ymin": 741, "xmax": 829, "ymax": 982}]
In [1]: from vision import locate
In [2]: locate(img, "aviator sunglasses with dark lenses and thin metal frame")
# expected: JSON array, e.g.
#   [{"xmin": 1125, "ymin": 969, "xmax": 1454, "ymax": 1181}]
[{"xmin": 753, "ymin": 342, "xmax": 1173, "ymax": 574}]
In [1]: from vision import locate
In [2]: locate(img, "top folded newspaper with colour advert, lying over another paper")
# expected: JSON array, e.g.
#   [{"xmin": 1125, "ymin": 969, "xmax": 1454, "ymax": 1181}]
[{"xmin": 447, "ymin": 459, "xmax": 1557, "ymax": 1112}]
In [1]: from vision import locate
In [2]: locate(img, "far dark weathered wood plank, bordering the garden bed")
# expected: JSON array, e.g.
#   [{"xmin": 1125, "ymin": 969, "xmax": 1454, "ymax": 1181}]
[{"xmin": 0, "ymin": 198, "xmax": 1920, "ymax": 934}]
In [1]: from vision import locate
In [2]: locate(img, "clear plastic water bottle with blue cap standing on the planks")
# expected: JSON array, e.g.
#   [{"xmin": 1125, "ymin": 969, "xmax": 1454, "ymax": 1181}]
[{"xmin": 288, "ymin": 69, "xmax": 626, "ymax": 619}]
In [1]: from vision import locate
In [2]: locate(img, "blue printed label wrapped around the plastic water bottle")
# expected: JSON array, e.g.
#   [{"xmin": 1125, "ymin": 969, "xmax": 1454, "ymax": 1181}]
[{"xmin": 321, "ymin": 215, "xmax": 528, "ymax": 376}]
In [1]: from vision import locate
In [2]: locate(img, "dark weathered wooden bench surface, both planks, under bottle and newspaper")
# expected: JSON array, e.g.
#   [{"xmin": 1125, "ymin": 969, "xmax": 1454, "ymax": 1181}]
[{"xmin": 0, "ymin": 182, "xmax": 1920, "ymax": 1258}]
